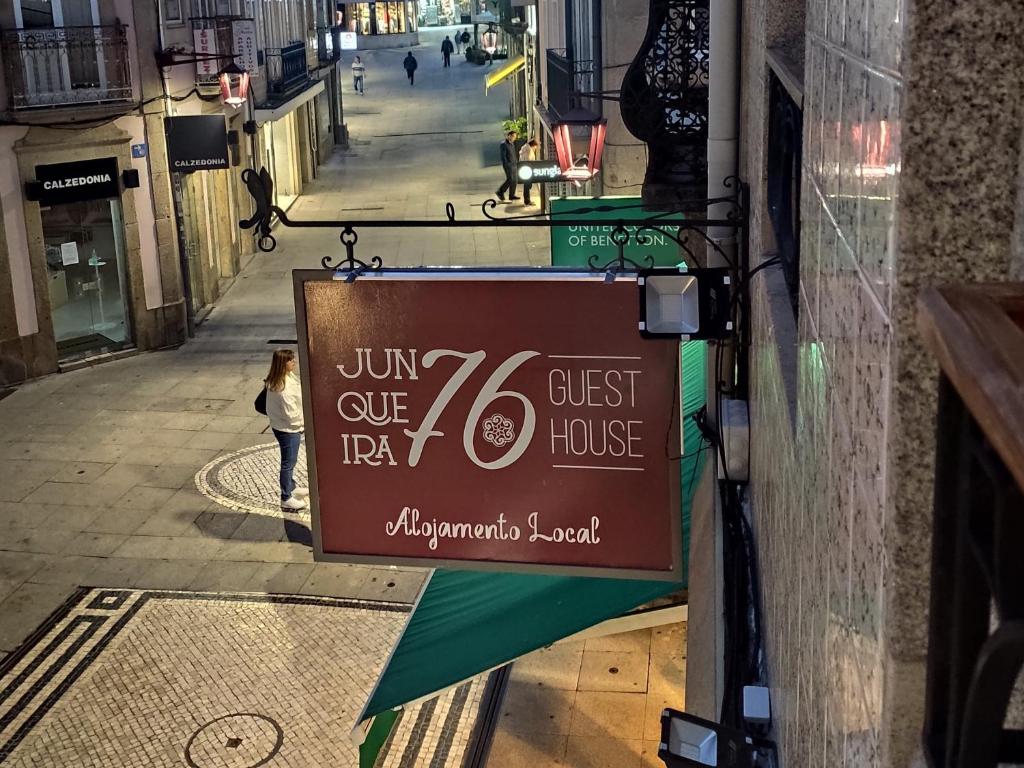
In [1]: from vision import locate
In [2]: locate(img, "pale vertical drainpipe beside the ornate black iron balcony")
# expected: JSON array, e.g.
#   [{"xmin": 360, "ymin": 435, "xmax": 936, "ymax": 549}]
[{"xmin": 708, "ymin": 0, "xmax": 739, "ymax": 266}]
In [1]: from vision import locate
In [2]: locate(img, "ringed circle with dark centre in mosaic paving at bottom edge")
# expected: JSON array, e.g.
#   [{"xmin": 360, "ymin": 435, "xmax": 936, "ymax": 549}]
[{"xmin": 185, "ymin": 713, "xmax": 285, "ymax": 768}]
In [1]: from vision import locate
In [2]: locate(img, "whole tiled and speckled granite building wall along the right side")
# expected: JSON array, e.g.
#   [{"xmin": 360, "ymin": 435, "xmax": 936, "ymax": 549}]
[{"xmin": 741, "ymin": 0, "xmax": 1024, "ymax": 768}]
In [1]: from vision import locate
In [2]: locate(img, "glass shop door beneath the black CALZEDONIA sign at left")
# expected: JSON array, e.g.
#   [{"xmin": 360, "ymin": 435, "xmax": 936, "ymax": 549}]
[{"xmin": 41, "ymin": 198, "xmax": 131, "ymax": 359}]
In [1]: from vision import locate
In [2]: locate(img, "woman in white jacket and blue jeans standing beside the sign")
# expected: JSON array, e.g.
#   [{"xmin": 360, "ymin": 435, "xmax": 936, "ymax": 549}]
[{"xmin": 264, "ymin": 349, "xmax": 309, "ymax": 512}]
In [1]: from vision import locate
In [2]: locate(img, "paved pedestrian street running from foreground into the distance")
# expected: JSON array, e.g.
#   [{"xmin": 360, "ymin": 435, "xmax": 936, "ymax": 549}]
[{"xmin": 0, "ymin": 30, "xmax": 547, "ymax": 766}]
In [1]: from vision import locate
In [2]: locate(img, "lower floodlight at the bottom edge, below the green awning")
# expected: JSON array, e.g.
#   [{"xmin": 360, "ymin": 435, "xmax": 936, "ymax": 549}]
[{"xmin": 657, "ymin": 710, "xmax": 755, "ymax": 768}]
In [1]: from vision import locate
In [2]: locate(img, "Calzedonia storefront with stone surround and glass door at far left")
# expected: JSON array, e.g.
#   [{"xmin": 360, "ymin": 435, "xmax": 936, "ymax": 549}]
[{"xmin": 0, "ymin": 116, "xmax": 185, "ymax": 383}]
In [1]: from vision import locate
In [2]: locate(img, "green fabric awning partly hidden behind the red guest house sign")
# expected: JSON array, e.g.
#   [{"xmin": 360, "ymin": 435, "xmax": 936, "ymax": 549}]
[{"xmin": 353, "ymin": 342, "xmax": 707, "ymax": 740}]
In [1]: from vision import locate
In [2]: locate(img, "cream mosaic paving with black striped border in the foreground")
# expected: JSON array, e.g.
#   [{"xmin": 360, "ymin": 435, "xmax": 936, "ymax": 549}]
[{"xmin": 0, "ymin": 589, "xmax": 492, "ymax": 768}]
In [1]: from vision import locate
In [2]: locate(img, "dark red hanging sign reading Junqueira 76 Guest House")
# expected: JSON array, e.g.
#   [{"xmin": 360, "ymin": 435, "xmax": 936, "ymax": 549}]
[{"xmin": 295, "ymin": 270, "xmax": 681, "ymax": 579}]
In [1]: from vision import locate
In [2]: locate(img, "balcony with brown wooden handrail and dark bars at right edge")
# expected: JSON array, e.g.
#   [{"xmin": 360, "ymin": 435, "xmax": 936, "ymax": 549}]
[{"xmin": 918, "ymin": 284, "xmax": 1024, "ymax": 768}]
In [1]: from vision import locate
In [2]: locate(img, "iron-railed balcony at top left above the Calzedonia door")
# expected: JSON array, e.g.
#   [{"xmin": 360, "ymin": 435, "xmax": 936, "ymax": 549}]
[{"xmin": 0, "ymin": 24, "xmax": 132, "ymax": 110}]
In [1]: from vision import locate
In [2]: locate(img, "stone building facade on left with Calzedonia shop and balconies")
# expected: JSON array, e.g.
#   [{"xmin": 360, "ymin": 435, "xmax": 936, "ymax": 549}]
[{"xmin": 0, "ymin": 0, "xmax": 345, "ymax": 386}]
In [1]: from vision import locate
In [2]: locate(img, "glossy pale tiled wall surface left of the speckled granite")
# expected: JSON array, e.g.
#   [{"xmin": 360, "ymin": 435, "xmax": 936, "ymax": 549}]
[{"xmin": 744, "ymin": 0, "xmax": 903, "ymax": 768}]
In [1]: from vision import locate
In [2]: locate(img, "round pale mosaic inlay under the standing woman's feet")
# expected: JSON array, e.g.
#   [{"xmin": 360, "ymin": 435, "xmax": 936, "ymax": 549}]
[{"xmin": 196, "ymin": 442, "xmax": 309, "ymax": 519}]
